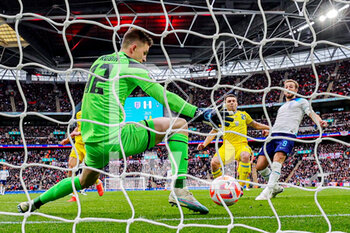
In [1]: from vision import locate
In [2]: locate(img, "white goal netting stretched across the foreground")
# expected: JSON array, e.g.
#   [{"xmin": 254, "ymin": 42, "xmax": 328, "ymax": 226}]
[{"xmin": 0, "ymin": 0, "xmax": 350, "ymax": 232}]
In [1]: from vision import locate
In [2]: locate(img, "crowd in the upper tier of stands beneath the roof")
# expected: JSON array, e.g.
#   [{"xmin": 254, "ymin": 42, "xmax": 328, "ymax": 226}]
[{"xmin": 0, "ymin": 61, "xmax": 350, "ymax": 112}]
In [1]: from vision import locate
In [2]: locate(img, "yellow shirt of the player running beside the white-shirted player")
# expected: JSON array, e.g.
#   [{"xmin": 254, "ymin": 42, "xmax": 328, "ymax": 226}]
[{"xmin": 223, "ymin": 111, "xmax": 253, "ymax": 144}]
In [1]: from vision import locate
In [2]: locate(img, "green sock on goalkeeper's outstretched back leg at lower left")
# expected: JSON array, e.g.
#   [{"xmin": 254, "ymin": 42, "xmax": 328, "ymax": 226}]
[{"xmin": 34, "ymin": 177, "xmax": 81, "ymax": 209}]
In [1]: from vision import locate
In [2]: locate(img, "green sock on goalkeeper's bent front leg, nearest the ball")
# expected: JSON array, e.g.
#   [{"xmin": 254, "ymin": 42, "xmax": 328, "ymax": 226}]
[{"xmin": 169, "ymin": 134, "xmax": 188, "ymax": 188}]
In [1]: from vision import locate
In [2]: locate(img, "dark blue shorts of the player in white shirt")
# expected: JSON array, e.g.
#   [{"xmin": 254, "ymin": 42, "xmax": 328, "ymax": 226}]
[{"xmin": 259, "ymin": 133, "xmax": 296, "ymax": 160}]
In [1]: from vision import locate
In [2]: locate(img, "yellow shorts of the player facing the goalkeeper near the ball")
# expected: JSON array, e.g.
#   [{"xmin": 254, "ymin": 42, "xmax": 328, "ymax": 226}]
[{"xmin": 214, "ymin": 140, "xmax": 252, "ymax": 165}]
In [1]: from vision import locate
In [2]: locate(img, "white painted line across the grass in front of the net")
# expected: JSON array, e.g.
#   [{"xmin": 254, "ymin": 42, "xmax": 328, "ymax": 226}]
[{"xmin": 0, "ymin": 214, "xmax": 350, "ymax": 225}]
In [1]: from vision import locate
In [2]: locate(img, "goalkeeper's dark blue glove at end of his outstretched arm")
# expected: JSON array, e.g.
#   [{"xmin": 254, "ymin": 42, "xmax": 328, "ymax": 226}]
[{"xmin": 194, "ymin": 108, "xmax": 234, "ymax": 128}]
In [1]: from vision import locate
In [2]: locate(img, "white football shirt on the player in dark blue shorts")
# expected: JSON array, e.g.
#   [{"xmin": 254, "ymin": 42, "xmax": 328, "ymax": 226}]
[{"xmin": 272, "ymin": 98, "xmax": 311, "ymax": 135}]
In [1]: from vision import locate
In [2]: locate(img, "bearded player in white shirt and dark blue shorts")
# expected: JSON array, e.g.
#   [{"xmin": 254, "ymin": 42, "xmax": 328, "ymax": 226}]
[{"xmin": 255, "ymin": 79, "xmax": 327, "ymax": 200}]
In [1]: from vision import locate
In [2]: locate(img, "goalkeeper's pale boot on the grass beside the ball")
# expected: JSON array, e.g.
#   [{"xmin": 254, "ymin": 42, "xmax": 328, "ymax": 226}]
[{"xmin": 169, "ymin": 188, "xmax": 209, "ymax": 214}]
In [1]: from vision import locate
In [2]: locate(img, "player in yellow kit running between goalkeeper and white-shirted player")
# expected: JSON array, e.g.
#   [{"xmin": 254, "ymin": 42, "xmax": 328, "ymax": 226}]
[{"xmin": 197, "ymin": 94, "xmax": 270, "ymax": 187}]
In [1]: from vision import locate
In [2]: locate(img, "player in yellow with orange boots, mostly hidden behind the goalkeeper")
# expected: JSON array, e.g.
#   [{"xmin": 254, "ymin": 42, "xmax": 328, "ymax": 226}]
[{"xmin": 60, "ymin": 111, "xmax": 104, "ymax": 202}]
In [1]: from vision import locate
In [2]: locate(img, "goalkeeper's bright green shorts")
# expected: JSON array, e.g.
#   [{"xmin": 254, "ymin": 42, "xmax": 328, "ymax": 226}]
[{"xmin": 85, "ymin": 120, "xmax": 156, "ymax": 169}]
